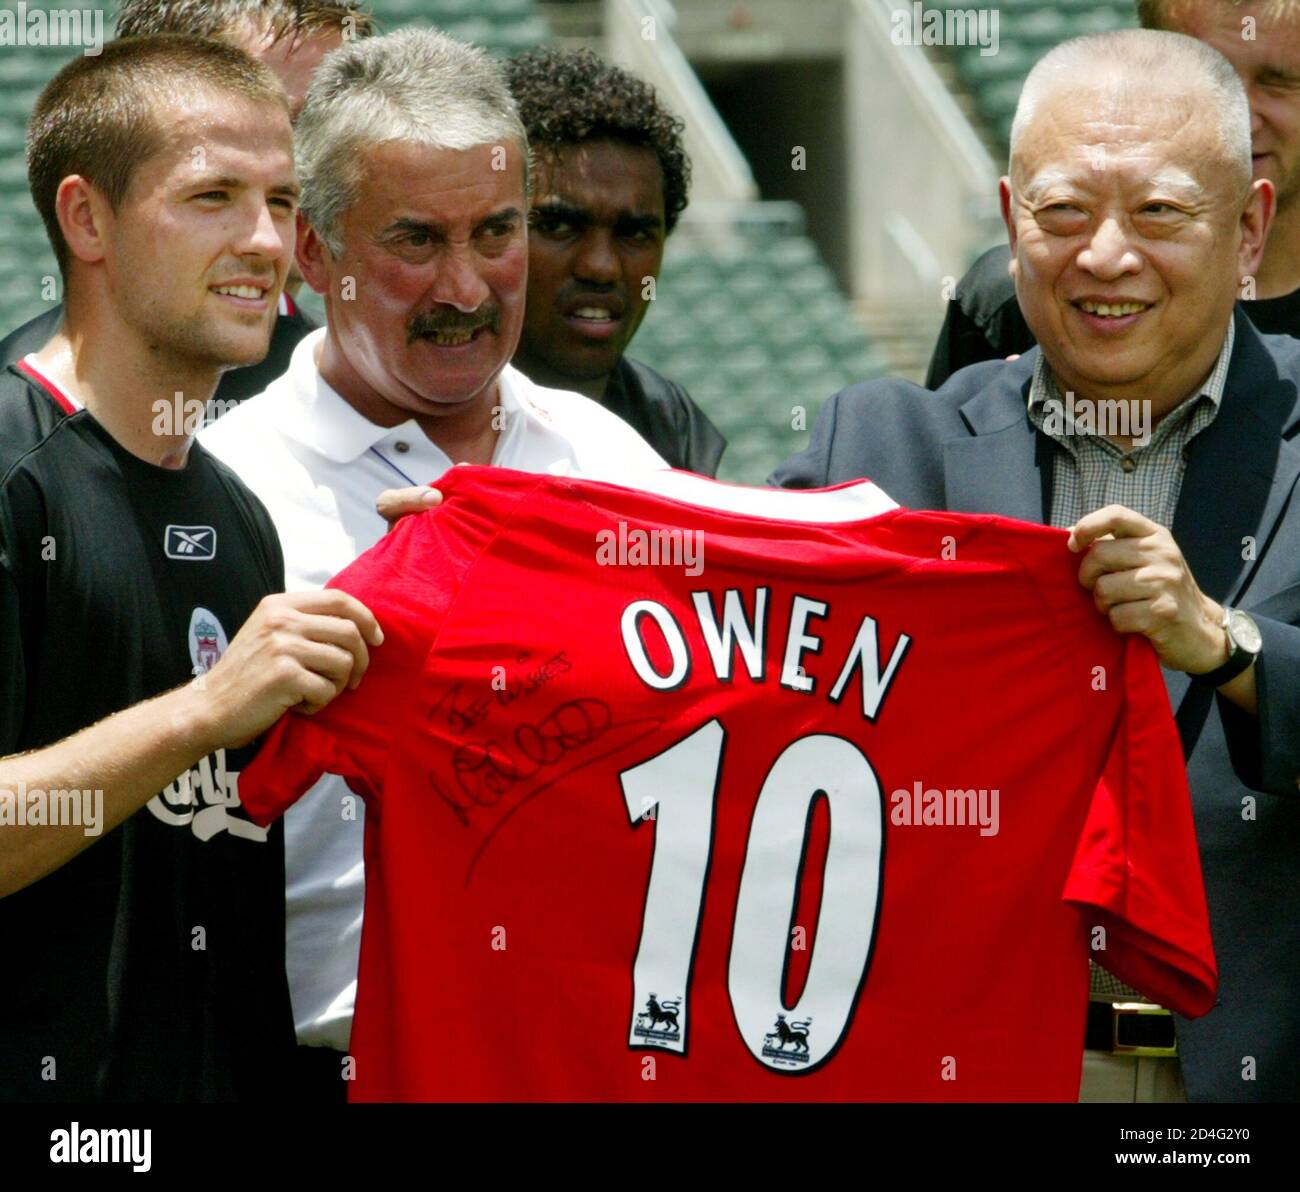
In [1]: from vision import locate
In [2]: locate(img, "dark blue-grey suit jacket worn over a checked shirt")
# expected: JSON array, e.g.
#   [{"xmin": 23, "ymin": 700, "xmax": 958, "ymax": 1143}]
[{"xmin": 772, "ymin": 311, "xmax": 1300, "ymax": 1101}]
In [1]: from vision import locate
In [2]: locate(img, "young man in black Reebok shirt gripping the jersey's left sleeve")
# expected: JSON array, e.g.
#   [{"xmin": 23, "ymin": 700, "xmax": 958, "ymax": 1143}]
[{"xmin": 0, "ymin": 36, "xmax": 382, "ymax": 1101}]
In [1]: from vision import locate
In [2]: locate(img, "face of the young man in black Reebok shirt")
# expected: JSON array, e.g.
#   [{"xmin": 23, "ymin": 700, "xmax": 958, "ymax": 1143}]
[{"xmin": 102, "ymin": 91, "xmax": 298, "ymax": 367}]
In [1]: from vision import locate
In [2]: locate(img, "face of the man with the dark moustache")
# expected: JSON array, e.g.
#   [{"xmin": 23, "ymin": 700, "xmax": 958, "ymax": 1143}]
[{"xmin": 299, "ymin": 142, "xmax": 528, "ymax": 422}]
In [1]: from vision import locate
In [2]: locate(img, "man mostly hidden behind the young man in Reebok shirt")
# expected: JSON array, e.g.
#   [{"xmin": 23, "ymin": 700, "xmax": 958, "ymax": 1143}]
[{"xmin": 0, "ymin": 0, "xmax": 372, "ymax": 405}]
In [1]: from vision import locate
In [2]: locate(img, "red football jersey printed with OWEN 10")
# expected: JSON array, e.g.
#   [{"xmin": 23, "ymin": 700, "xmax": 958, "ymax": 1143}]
[{"xmin": 239, "ymin": 467, "xmax": 1217, "ymax": 1101}]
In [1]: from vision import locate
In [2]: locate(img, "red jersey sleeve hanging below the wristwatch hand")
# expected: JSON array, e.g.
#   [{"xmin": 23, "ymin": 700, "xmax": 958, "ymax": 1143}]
[{"xmin": 1062, "ymin": 636, "xmax": 1218, "ymax": 1018}]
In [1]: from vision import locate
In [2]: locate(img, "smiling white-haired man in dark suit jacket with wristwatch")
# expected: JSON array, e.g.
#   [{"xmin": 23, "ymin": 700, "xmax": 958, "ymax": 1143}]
[{"xmin": 774, "ymin": 30, "xmax": 1300, "ymax": 1101}]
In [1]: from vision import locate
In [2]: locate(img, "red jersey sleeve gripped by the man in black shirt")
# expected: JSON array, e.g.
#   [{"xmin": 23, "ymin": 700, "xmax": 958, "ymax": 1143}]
[{"xmin": 239, "ymin": 468, "xmax": 541, "ymax": 825}]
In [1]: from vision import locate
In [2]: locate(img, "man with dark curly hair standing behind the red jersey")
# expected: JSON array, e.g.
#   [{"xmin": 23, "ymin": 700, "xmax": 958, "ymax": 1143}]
[{"xmin": 507, "ymin": 48, "xmax": 727, "ymax": 476}]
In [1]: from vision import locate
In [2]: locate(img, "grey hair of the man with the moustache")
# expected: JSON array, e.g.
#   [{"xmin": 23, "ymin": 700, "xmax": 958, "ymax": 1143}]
[{"xmin": 294, "ymin": 27, "xmax": 528, "ymax": 257}]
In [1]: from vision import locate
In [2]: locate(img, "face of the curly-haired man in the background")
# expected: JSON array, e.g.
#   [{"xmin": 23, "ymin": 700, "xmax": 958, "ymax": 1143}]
[{"xmin": 519, "ymin": 140, "xmax": 664, "ymax": 390}]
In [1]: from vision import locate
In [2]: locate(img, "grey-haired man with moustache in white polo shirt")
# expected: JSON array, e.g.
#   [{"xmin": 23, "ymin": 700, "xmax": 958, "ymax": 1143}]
[{"xmin": 200, "ymin": 30, "xmax": 666, "ymax": 1101}]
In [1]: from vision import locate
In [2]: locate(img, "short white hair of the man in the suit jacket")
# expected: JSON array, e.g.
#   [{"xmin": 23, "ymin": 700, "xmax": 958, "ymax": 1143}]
[{"xmin": 1011, "ymin": 29, "xmax": 1251, "ymax": 191}]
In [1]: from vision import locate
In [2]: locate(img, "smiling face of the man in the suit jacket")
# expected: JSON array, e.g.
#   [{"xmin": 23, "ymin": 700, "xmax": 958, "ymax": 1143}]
[{"xmin": 1002, "ymin": 71, "xmax": 1271, "ymax": 416}]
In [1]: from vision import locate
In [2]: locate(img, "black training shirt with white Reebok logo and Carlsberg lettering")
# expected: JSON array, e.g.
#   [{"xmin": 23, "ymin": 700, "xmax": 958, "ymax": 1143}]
[{"xmin": 0, "ymin": 367, "xmax": 294, "ymax": 1101}]
